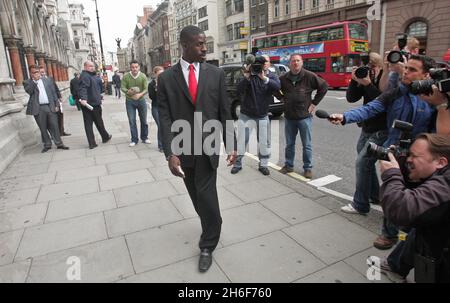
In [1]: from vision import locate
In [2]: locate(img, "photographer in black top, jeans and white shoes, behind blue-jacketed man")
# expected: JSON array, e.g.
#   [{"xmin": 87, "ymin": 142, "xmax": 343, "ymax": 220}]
[{"xmin": 341, "ymin": 52, "xmax": 387, "ymax": 214}]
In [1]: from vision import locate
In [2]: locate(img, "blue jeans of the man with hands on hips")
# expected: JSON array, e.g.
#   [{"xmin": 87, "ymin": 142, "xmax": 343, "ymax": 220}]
[{"xmin": 285, "ymin": 116, "xmax": 313, "ymax": 170}]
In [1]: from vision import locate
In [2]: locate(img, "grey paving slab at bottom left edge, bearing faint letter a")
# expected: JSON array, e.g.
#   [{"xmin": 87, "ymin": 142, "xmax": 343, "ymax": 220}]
[{"xmin": 27, "ymin": 237, "xmax": 134, "ymax": 283}]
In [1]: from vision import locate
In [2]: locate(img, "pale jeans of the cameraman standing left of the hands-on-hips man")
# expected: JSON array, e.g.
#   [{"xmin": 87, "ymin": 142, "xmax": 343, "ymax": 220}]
[{"xmin": 234, "ymin": 113, "xmax": 271, "ymax": 168}]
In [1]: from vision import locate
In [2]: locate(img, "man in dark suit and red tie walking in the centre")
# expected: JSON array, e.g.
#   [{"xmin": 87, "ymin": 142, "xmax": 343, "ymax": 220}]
[{"xmin": 158, "ymin": 26, "xmax": 237, "ymax": 272}]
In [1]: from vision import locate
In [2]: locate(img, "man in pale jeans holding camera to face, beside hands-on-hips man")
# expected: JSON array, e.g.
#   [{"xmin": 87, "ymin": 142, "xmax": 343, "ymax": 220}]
[{"xmin": 231, "ymin": 55, "xmax": 280, "ymax": 176}]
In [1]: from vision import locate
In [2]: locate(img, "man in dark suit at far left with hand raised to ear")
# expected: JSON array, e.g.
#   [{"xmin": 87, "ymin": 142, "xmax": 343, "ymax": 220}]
[{"xmin": 23, "ymin": 65, "xmax": 69, "ymax": 153}]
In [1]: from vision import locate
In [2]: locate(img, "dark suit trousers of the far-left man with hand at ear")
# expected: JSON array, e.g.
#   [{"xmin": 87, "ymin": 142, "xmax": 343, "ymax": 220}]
[{"xmin": 34, "ymin": 104, "xmax": 63, "ymax": 148}]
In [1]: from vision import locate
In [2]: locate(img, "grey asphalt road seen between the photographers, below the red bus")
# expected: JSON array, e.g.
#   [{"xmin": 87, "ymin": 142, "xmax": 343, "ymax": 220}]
[{"xmin": 244, "ymin": 90, "xmax": 368, "ymax": 200}]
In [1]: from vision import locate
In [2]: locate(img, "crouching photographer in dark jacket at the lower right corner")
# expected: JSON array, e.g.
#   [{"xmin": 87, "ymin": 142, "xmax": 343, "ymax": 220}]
[{"xmin": 380, "ymin": 134, "xmax": 450, "ymax": 283}]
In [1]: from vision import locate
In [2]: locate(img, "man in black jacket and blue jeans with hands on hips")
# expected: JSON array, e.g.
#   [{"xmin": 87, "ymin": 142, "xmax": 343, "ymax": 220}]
[{"xmin": 275, "ymin": 54, "xmax": 328, "ymax": 179}]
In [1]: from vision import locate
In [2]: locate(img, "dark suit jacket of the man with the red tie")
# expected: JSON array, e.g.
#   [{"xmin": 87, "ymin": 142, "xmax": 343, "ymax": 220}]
[{"xmin": 157, "ymin": 63, "xmax": 236, "ymax": 168}]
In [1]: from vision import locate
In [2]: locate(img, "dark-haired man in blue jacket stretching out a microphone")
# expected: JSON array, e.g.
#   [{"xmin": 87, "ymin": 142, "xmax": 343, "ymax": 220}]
[{"xmin": 329, "ymin": 55, "xmax": 434, "ymax": 249}]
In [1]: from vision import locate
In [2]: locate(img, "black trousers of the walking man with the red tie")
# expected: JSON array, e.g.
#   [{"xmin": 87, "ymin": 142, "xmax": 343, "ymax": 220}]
[{"xmin": 183, "ymin": 156, "xmax": 222, "ymax": 251}]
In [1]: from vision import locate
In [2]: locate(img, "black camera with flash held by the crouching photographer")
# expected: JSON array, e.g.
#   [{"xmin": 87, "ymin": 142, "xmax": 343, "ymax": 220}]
[{"xmin": 367, "ymin": 120, "xmax": 414, "ymax": 162}]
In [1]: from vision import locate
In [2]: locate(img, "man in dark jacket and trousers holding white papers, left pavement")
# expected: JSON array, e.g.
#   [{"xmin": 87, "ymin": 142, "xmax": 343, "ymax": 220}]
[{"xmin": 78, "ymin": 61, "xmax": 112, "ymax": 149}]
